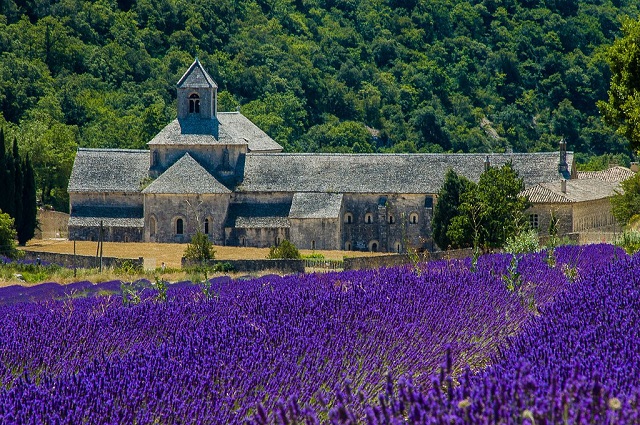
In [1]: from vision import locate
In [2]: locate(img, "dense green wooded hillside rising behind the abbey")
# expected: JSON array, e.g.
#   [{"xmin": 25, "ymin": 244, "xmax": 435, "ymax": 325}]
[{"xmin": 0, "ymin": 0, "xmax": 638, "ymax": 208}]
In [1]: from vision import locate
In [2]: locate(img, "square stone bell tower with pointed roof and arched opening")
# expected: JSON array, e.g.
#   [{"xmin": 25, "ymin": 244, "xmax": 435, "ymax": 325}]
[{"xmin": 177, "ymin": 58, "xmax": 218, "ymax": 120}]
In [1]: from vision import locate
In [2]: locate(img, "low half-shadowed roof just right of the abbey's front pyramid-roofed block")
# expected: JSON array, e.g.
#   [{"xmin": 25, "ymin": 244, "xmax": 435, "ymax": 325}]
[{"xmin": 225, "ymin": 203, "xmax": 291, "ymax": 229}]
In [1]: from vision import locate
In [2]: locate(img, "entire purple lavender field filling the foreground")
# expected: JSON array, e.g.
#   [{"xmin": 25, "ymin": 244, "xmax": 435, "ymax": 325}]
[{"xmin": 0, "ymin": 245, "xmax": 640, "ymax": 424}]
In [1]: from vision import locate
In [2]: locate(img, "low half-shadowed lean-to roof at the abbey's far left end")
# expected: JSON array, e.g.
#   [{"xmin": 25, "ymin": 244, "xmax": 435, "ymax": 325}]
[{"xmin": 69, "ymin": 205, "xmax": 144, "ymax": 227}]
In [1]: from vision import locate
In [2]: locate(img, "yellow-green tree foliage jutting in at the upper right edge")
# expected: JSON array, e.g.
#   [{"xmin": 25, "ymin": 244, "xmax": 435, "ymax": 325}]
[{"xmin": 598, "ymin": 19, "xmax": 640, "ymax": 152}]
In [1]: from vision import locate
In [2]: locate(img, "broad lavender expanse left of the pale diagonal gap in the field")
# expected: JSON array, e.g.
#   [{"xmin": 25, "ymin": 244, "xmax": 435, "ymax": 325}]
[{"xmin": 0, "ymin": 243, "xmax": 613, "ymax": 423}]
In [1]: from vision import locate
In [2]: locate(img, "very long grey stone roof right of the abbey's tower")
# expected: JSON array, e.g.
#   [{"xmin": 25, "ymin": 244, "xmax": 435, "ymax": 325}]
[{"xmin": 237, "ymin": 152, "xmax": 573, "ymax": 194}]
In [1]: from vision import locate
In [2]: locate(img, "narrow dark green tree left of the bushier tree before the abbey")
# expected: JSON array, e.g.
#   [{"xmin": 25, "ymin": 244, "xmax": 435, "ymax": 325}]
[{"xmin": 432, "ymin": 169, "xmax": 472, "ymax": 249}]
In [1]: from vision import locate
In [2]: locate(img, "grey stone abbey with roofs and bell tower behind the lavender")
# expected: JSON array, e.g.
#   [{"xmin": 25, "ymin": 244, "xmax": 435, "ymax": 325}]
[{"xmin": 69, "ymin": 60, "xmax": 599, "ymax": 252}]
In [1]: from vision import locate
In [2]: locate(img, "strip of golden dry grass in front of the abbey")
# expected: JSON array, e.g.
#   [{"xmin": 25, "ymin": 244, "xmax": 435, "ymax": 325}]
[{"xmin": 23, "ymin": 239, "xmax": 380, "ymax": 268}]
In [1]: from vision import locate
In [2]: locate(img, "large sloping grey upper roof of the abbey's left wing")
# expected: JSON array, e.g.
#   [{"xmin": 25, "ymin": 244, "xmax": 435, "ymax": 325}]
[{"xmin": 67, "ymin": 149, "xmax": 149, "ymax": 192}]
